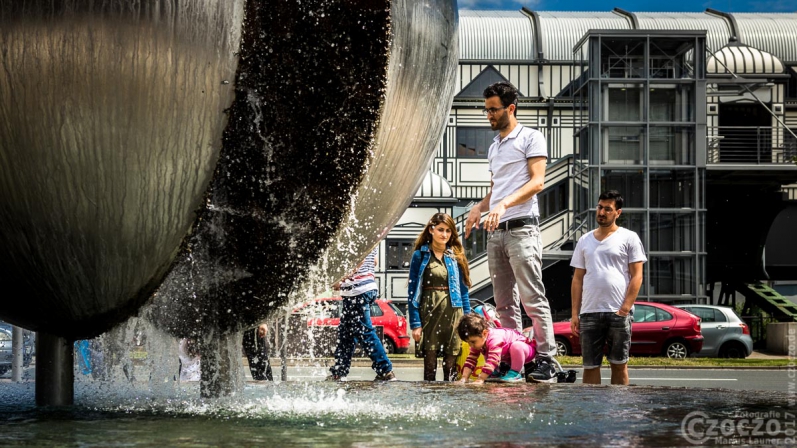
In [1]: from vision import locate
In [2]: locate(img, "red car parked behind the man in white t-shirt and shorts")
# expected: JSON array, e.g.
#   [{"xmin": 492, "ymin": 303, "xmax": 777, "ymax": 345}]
[{"xmin": 553, "ymin": 302, "xmax": 703, "ymax": 358}]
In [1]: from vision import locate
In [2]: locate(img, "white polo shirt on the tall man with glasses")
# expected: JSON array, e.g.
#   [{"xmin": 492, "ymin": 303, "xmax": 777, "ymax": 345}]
[{"xmin": 487, "ymin": 123, "xmax": 548, "ymax": 222}]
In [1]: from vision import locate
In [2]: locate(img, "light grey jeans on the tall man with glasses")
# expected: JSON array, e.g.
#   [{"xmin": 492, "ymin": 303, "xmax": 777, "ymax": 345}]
[{"xmin": 487, "ymin": 224, "xmax": 556, "ymax": 357}]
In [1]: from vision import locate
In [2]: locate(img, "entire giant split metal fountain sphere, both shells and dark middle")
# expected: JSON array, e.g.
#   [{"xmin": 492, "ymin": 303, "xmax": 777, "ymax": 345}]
[{"xmin": 0, "ymin": 0, "xmax": 457, "ymax": 338}]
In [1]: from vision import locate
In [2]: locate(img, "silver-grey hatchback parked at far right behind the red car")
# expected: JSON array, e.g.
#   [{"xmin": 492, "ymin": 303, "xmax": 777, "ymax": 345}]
[{"xmin": 675, "ymin": 305, "xmax": 753, "ymax": 358}]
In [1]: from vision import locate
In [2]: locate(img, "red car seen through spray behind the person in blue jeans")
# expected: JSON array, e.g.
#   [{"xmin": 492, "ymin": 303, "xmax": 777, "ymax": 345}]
[{"xmin": 293, "ymin": 297, "xmax": 410, "ymax": 353}]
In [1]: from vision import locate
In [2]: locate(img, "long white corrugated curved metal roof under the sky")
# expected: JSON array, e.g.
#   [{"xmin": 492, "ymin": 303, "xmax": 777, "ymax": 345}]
[{"xmin": 459, "ymin": 9, "xmax": 797, "ymax": 65}]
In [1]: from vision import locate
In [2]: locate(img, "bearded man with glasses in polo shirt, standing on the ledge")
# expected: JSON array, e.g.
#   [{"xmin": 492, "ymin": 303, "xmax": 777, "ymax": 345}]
[{"xmin": 465, "ymin": 82, "xmax": 556, "ymax": 382}]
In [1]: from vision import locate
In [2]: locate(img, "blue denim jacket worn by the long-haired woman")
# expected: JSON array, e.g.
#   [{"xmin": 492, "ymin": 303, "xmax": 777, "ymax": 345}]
[{"xmin": 407, "ymin": 244, "xmax": 470, "ymax": 330}]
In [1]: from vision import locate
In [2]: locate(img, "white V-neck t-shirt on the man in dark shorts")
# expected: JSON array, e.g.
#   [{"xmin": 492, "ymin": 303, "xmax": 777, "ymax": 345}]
[{"xmin": 570, "ymin": 227, "xmax": 648, "ymax": 313}]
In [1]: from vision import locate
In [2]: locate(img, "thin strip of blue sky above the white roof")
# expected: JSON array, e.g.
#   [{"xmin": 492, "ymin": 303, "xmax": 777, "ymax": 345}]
[{"xmin": 457, "ymin": 0, "xmax": 797, "ymax": 12}]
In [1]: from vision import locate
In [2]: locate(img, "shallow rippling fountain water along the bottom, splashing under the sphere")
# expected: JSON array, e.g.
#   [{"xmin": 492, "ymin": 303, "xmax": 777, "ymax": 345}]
[{"xmin": 0, "ymin": 382, "xmax": 794, "ymax": 447}]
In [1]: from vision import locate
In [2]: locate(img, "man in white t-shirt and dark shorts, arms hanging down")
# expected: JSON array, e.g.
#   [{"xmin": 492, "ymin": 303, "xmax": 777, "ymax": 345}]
[{"xmin": 570, "ymin": 190, "xmax": 647, "ymax": 385}]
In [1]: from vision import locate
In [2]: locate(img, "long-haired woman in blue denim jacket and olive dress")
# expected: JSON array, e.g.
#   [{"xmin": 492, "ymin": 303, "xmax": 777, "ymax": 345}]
[{"xmin": 407, "ymin": 213, "xmax": 471, "ymax": 381}]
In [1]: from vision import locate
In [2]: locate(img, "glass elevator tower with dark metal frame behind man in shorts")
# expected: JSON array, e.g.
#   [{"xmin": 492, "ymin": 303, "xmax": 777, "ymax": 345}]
[{"xmin": 573, "ymin": 30, "xmax": 706, "ymax": 302}]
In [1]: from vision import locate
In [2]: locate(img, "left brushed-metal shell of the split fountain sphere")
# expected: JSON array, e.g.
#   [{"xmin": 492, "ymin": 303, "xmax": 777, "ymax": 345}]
[{"xmin": 0, "ymin": 0, "xmax": 243, "ymax": 337}]
